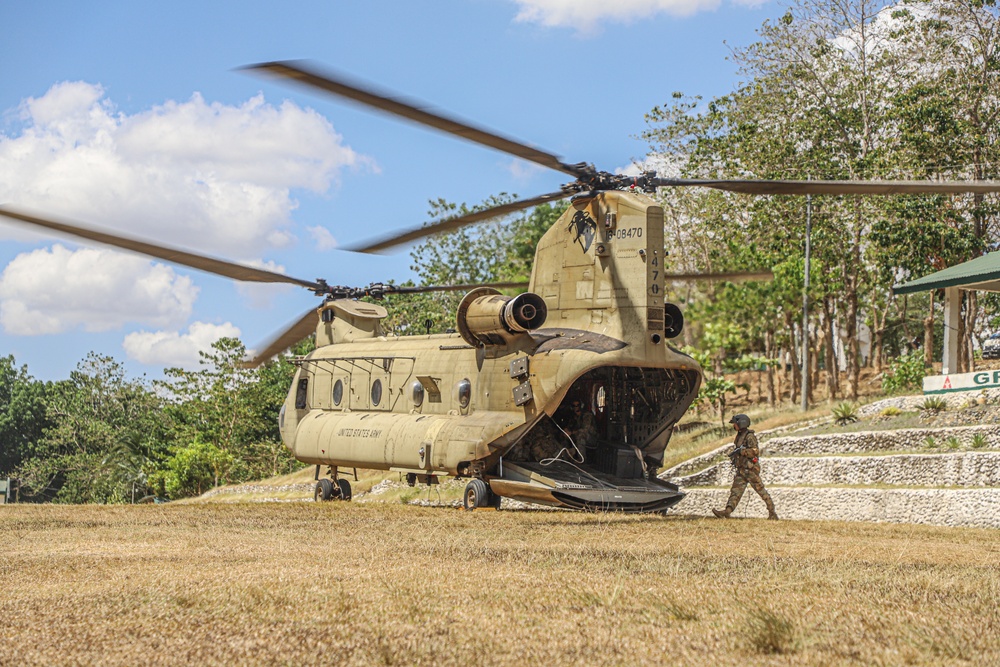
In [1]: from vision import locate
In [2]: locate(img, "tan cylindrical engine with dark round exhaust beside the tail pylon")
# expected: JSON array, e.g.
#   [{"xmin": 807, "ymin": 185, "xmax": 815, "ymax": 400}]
[{"xmin": 458, "ymin": 287, "xmax": 548, "ymax": 347}]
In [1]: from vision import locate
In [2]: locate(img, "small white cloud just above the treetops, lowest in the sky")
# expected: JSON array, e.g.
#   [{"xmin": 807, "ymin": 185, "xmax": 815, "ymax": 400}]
[{"xmin": 122, "ymin": 322, "xmax": 240, "ymax": 370}]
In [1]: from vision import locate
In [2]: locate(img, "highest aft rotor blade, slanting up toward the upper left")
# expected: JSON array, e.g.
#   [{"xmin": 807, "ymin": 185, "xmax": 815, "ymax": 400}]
[{"xmin": 243, "ymin": 61, "xmax": 589, "ymax": 178}]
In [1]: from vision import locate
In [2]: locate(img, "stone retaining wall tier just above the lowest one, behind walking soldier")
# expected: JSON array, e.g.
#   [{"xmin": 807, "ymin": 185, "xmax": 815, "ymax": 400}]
[{"xmin": 670, "ymin": 452, "xmax": 1000, "ymax": 488}]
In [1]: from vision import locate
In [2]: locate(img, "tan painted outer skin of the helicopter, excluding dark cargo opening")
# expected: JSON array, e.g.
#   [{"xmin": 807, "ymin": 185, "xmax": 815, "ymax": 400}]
[{"xmin": 282, "ymin": 192, "xmax": 699, "ymax": 482}]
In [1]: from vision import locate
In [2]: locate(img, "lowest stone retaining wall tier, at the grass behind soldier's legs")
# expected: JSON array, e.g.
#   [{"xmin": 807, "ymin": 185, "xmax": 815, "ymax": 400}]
[{"xmin": 671, "ymin": 488, "xmax": 1000, "ymax": 528}]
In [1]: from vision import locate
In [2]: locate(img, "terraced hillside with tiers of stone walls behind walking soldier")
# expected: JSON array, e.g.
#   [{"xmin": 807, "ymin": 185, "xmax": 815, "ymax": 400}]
[{"xmin": 662, "ymin": 398, "xmax": 1000, "ymax": 528}]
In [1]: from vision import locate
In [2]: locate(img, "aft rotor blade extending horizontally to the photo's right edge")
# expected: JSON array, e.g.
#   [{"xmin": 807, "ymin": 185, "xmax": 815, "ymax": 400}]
[{"xmin": 654, "ymin": 178, "xmax": 1000, "ymax": 195}]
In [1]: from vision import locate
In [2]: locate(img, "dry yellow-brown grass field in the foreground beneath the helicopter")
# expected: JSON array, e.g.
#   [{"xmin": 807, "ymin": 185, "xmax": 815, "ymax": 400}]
[{"xmin": 0, "ymin": 503, "xmax": 1000, "ymax": 665}]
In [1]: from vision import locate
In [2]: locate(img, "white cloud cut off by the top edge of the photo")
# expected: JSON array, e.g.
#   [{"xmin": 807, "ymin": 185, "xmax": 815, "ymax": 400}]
[{"xmin": 514, "ymin": 0, "xmax": 728, "ymax": 33}]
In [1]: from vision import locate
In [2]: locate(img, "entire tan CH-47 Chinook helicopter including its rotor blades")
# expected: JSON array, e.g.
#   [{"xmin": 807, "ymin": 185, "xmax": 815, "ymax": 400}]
[{"xmin": 0, "ymin": 62, "xmax": 1000, "ymax": 512}]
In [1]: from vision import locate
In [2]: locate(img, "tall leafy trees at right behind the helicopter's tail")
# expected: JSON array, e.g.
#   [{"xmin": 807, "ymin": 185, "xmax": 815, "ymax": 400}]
[{"xmin": 643, "ymin": 0, "xmax": 1000, "ymax": 398}]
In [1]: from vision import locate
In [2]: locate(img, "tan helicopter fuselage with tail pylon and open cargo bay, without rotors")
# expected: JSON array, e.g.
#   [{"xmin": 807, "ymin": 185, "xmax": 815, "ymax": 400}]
[{"xmin": 281, "ymin": 192, "xmax": 701, "ymax": 509}]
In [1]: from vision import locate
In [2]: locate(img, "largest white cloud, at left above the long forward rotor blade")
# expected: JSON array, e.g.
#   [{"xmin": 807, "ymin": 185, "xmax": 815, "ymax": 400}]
[{"xmin": 0, "ymin": 82, "xmax": 372, "ymax": 259}]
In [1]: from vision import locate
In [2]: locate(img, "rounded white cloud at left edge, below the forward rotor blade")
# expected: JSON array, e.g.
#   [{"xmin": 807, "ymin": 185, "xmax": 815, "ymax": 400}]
[{"xmin": 0, "ymin": 244, "xmax": 198, "ymax": 336}]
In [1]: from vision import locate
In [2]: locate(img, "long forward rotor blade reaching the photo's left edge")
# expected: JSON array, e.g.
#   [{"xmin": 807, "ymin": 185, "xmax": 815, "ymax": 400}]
[{"xmin": 0, "ymin": 206, "xmax": 323, "ymax": 290}]
